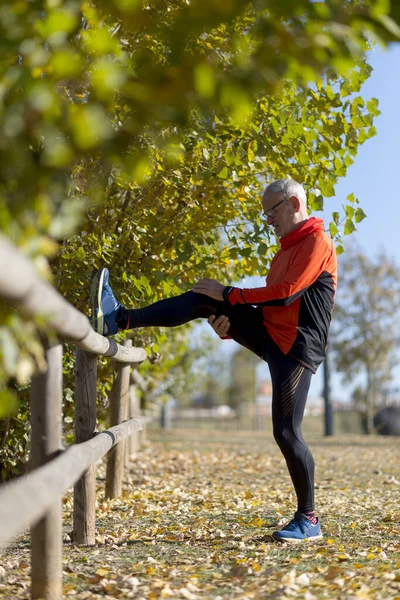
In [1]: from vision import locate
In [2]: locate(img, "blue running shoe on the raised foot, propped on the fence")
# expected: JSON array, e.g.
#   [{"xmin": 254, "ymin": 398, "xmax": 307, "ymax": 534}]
[{"xmin": 90, "ymin": 268, "xmax": 121, "ymax": 336}]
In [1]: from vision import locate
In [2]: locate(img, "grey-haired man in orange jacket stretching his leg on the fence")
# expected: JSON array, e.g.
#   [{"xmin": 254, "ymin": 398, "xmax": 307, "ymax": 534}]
[{"xmin": 92, "ymin": 179, "xmax": 337, "ymax": 542}]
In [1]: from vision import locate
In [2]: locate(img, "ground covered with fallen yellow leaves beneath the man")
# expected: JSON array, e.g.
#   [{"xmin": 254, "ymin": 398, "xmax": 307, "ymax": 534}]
[{"xmin": 0, "ymin": 431, "xmax": 400, "ymax": 600}]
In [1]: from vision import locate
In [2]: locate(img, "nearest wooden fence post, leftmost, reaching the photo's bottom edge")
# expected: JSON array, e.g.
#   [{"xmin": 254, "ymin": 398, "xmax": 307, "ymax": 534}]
[{"xmin": 31, "ymin": 342, "xmax": 63, "ymax": 600}]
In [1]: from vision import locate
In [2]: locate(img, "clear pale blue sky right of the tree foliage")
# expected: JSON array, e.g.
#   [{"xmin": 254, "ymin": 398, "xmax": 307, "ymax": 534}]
[{"xmin": 206, "ymin": 44, "xmax": 400, "ymax": 401}]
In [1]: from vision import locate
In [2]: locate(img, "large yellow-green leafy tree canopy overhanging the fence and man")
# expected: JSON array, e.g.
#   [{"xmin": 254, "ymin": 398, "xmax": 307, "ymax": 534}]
[{"xmin": 0, "ymin": 0, "xmax": 400, "ymax": 418}]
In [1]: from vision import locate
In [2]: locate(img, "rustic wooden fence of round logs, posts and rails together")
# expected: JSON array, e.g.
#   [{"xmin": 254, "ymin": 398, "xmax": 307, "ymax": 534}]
[{"xmin": 0, "ymin": 235, "xmax": 146, "ymax": 600}]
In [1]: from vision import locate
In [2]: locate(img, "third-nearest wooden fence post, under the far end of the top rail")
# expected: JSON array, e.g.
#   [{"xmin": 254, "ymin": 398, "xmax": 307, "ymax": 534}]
[{"xmin": 105, "ymin": 339, "xmax": 132, "ymax": 498}]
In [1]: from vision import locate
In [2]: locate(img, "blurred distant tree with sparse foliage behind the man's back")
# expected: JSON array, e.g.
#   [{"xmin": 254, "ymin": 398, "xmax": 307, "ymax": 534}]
[{"xmin": 331, "ymin": 247, "xmax": 400, "ymax": 433}]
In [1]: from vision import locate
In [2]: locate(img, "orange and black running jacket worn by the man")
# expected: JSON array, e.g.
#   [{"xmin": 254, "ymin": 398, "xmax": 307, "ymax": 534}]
[{"xmin": 227, "ymin": 217, "xmax": 337, "ymax": 372}]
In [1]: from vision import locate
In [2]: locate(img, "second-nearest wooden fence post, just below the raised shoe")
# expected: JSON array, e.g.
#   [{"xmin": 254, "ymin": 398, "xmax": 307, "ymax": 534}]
[{"xmin": 72, "ymin": 348, "xmax": 97, "ymax": 546}]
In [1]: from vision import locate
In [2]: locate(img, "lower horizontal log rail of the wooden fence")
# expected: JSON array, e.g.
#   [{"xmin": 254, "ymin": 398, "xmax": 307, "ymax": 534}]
[{"xmin": 0, "ymin": 419, "xmax": 142, "ymax": 548}]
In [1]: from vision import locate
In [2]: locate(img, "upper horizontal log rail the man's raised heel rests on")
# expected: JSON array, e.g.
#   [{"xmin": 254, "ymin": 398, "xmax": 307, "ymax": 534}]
[{"xmin": 0, "ymin": 235, "xmax": 146, "ymax": 363}]
